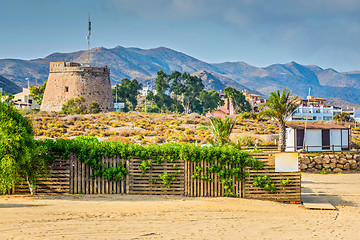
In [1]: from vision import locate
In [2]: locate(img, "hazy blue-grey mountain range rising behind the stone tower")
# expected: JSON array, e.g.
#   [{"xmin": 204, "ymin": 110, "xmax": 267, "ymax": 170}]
[{"xmin": 0, "ymin": 46, "xmax": 360, "ymax": 105}]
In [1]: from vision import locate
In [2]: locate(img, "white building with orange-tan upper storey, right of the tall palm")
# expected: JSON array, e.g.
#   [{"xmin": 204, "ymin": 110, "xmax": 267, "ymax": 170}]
[{"xmin": 290, "ymin": 96, "xmax": 342, "ymax": 121}]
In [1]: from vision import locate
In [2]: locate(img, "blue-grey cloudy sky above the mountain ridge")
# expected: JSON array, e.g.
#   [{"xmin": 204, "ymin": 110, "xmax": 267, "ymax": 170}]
[{"xmin": 0, "ymin": 0, "xmax": 360, "ymax": 72}]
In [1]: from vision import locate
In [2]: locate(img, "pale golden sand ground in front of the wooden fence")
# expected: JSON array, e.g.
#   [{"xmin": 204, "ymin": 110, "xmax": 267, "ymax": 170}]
[{"xmin": 0, "ymin": 174, "xmax": 360, "ymax": 239}]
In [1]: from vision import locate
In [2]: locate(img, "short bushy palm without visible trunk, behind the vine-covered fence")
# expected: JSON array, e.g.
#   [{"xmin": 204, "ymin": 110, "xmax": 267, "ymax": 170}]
[{"xmin": 197, "ymin": 116, "xmax": 238, "ymax": 146}]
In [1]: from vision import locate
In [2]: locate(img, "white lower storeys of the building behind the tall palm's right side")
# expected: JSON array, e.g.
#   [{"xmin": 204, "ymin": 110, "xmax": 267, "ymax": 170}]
[{"xmin": 291, "ymin": 105, "xmax": 342, "ymax": 121}]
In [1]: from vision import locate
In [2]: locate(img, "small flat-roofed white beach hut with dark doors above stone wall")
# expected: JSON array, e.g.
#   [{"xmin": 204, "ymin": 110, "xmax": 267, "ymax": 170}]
[{"xmin": 286, "ymin": 124, "xmax": 350, "ymax": 152}]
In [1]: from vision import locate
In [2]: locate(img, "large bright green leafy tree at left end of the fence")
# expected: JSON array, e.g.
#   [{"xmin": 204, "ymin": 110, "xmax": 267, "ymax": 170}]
[{"xmin": 0, "ymin": 98, "xmax": 47, "ymax": 194}]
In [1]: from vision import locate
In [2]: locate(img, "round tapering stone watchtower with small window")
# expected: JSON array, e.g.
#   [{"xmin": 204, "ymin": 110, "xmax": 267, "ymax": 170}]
[{"xmin": 40, "ymin": 62, "xmax": 114, "ymax": 112}]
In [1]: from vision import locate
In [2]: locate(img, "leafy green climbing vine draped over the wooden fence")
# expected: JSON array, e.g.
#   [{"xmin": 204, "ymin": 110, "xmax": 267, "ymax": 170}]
[{"xmin": 41, "ymin": 137, "xmax": 263, "ymax": 196}]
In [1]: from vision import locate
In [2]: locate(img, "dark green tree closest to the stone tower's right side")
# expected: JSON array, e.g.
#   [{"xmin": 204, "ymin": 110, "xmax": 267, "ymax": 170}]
[{"xmin": 112, "ymin": 78, "xmax": 142, "ymax": 111}]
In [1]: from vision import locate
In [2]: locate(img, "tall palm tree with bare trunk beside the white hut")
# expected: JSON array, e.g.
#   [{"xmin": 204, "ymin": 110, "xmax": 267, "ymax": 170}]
[{"xmin": 260, "ymin": 88, "xmax": 300, "ymax": 152}]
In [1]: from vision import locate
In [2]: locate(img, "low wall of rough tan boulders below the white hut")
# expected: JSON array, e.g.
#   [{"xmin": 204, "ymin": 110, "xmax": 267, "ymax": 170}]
[{"xmin": 299, "ymin": 152, "xmax": 360, "ymax": 173}]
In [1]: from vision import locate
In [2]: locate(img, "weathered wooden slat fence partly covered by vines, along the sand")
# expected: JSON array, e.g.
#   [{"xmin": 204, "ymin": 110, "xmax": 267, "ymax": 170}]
[{"xmin": 9, "ymin": 153, "xmax": 301, "ymax": 202}]
